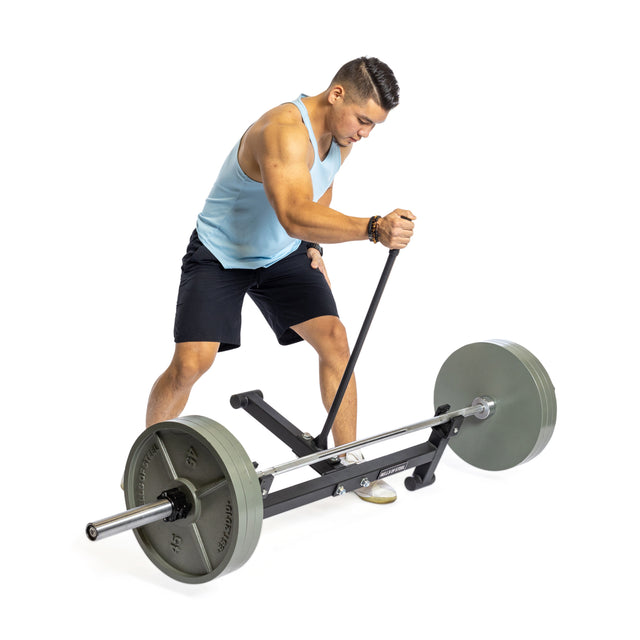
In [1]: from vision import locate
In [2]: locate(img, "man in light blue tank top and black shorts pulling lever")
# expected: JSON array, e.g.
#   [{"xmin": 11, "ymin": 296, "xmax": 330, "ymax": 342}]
[{"xmin": 147, "ymin": 58, "xmax": 415, "ymax": 502}]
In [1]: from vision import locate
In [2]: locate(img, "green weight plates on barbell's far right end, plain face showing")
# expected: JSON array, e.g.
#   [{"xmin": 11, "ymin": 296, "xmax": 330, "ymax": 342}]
[{"xmin": 434, "ymin": 340, "xmax": 556, "ymax": 471}]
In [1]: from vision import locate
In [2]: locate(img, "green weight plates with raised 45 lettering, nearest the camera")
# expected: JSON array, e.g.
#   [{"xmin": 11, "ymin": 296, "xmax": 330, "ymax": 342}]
[{"xmin": 124, "ymin": 416, "xmax": 263, "ymax": 583}]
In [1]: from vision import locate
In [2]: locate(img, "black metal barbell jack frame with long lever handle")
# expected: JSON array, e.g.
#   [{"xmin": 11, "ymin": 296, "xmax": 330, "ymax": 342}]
[{"xmin": 231, "ymin": 249, "xmax": 464, "ymax": 518}]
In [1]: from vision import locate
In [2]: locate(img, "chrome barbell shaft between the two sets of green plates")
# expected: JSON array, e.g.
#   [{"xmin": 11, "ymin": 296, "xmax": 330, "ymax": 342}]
[{"xmin": 257, "ymin": 398, "xmax": 493, "ymax": 478}]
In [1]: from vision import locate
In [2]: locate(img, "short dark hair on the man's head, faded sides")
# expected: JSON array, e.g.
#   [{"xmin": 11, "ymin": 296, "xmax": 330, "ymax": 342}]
[{"xmin": 331, "ymin": 57, "xmax": 400, "ymax": 111}]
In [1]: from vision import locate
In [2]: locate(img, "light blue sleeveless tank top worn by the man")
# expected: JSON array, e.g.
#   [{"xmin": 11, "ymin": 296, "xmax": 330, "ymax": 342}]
[{"xmin": 196, "ymin": 94, "xmax": 341, "ymax": 269}]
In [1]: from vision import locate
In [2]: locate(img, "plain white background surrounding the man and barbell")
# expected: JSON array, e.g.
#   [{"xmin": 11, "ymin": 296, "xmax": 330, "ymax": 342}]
[{"xmin": 0, "ymin": 0, "xmax": 640, "ymax": 638}]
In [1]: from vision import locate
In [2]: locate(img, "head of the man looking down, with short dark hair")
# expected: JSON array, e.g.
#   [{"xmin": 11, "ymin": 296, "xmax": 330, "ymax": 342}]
[{"xmin": 327, "ymin": 58, "xmax": 399, "ymax": 147}]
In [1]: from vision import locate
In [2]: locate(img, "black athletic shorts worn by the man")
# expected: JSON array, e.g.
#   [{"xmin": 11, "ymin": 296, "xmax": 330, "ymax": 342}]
[{"xmin": 173, "ymin": 231, "xmax": 338, "ymax": 351}]
